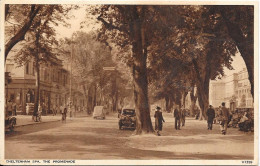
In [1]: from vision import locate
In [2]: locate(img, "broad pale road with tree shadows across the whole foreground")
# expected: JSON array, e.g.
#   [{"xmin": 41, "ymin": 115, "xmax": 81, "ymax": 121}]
[{"xmin": 5, "ymin": 114, "xmax": 254, "ymax": 160}]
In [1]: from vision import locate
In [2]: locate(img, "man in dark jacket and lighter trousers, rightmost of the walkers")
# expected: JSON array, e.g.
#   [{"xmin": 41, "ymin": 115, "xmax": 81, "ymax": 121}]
[{"xmin": 219, "ymin": 102, "xmax": 229, "ymax": 135}]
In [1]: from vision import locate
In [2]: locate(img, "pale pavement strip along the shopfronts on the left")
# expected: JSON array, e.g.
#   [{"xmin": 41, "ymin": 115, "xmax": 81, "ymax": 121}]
[{"xmin": 15, "ymin": 112, "xmax": 89, "ymax": 127}]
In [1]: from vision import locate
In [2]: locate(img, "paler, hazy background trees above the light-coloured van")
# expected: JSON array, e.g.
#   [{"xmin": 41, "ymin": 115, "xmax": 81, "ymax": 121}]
[{"xmin": 60, "ymin": 31, "xmax": 131, "ymax": 113}]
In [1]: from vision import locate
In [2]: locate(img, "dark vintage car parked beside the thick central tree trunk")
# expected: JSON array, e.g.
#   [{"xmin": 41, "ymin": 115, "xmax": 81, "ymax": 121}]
[{"xmin": 118, "ymin": 108, "xmax": 136, "ymax": 130}]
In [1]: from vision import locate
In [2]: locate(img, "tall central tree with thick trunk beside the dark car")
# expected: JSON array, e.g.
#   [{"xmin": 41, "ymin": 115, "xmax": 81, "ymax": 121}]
[{"xmin": 93, "ymin": 5, "xmax": 185, "ymax": 134}]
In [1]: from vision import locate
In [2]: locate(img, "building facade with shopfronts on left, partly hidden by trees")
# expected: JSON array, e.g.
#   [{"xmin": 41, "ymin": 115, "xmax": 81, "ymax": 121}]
[{"xmin": 5, "ymin": 55, "xmax": 86, "ymax": 114}]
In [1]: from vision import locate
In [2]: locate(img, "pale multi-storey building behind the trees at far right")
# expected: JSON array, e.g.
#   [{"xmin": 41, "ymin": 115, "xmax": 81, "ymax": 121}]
[{"xmin": 209, "ymin": 68, "xmax": 253, "ymax": 109}]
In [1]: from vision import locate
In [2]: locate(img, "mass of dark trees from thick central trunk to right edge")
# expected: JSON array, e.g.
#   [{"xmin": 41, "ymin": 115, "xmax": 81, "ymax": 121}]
[{"xmin": 92, "ymin": 5, "xmax": 254, "ymax": 134}]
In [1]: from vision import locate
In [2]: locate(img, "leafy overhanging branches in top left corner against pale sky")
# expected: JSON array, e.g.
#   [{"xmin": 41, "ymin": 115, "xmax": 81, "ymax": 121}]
[{"xmin": 5, "ymin": 4, "xmax": 77, "ymax": 59}]
